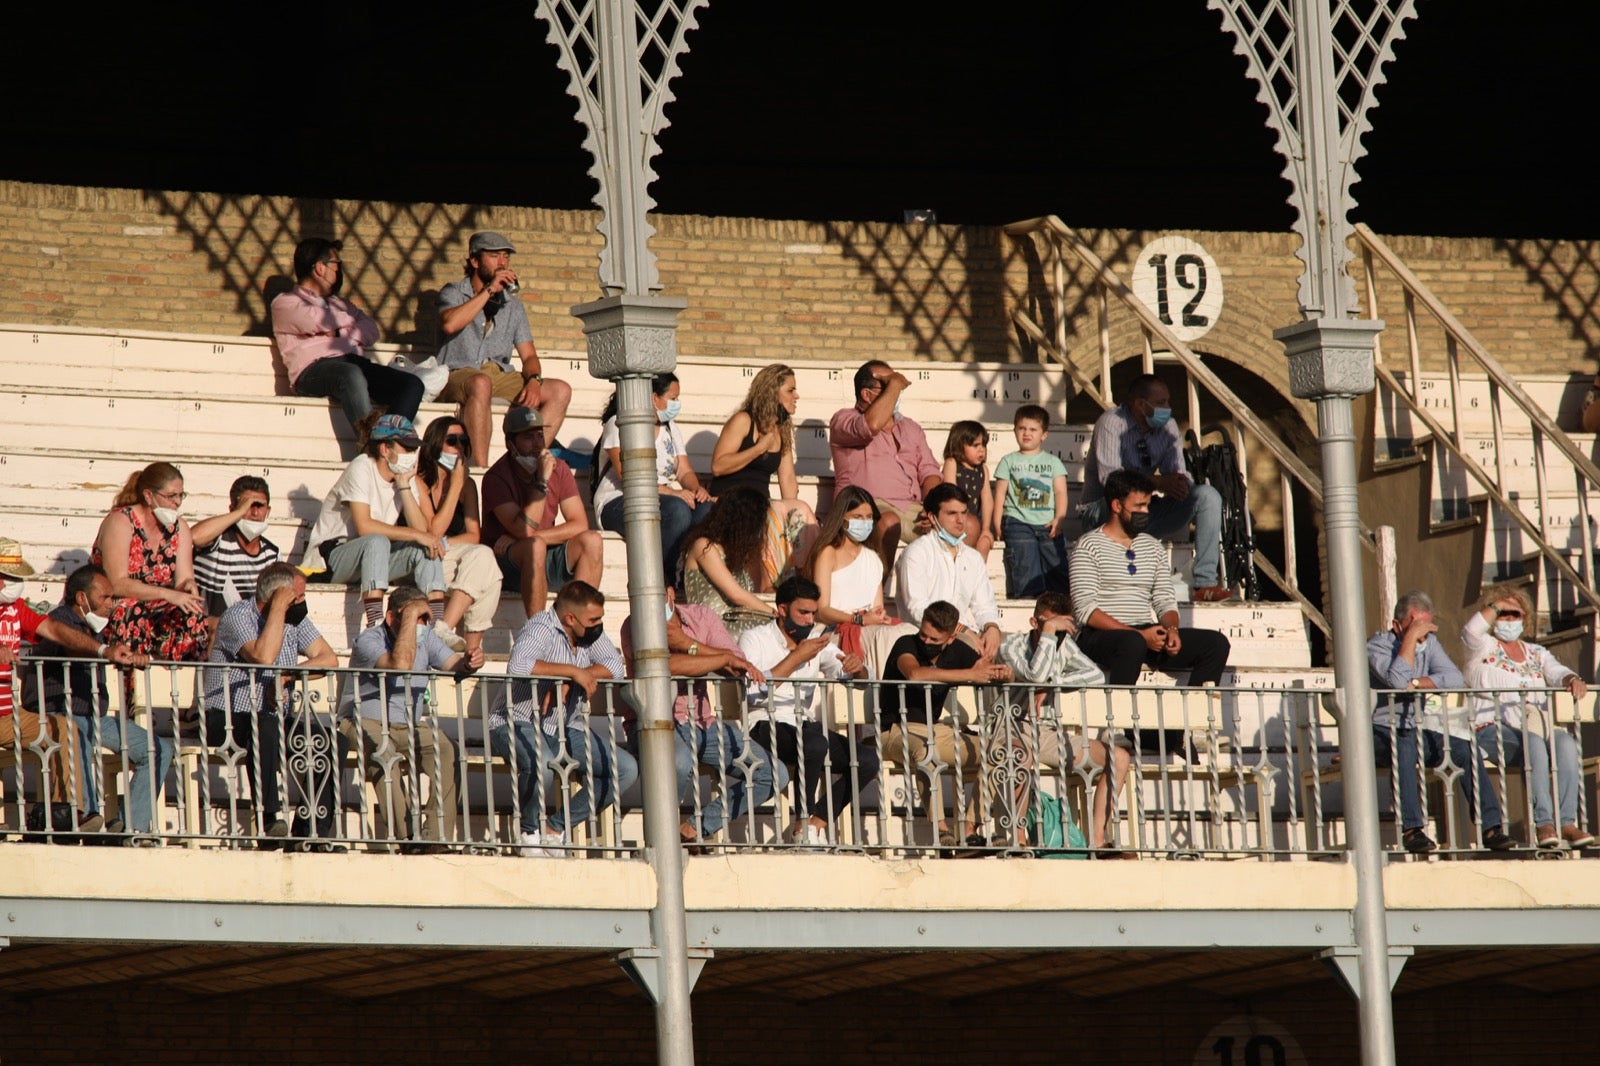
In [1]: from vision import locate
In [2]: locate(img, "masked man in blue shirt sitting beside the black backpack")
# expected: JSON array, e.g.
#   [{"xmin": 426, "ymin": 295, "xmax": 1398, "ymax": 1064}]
[{"xmin": 1078, "ymin": 375, "xmax": 1234, "ymax": 603}]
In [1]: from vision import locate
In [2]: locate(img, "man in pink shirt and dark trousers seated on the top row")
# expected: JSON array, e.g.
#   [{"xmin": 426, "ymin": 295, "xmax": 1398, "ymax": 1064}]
[{"xmin": 272, "ymin": 237, "xmax": 422, "ymax": 426}]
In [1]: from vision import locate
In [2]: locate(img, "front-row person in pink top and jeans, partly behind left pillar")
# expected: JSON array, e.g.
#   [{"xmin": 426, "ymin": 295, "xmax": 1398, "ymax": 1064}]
[{"xmin": 622, "ymin": 589, "xmax": 787, "ymax": 844}]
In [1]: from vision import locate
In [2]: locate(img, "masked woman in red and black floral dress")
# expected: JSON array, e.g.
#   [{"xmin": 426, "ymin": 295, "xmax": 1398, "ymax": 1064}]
[{"xmin": 91, "ymin": 463, "xmax": 208, "ymax": 665}]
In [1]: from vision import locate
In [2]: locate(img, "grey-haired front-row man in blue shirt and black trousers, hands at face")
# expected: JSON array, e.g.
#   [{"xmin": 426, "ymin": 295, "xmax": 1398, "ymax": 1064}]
[{"xmin": 202, "ymin": 563, "xmax": 344, "ymax": 852}]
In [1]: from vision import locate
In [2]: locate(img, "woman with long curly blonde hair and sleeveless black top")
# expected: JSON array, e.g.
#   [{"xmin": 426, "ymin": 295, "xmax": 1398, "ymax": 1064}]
[{"xmin": 710, "ymin": 363, "xmax": 816, "ymax": 592}]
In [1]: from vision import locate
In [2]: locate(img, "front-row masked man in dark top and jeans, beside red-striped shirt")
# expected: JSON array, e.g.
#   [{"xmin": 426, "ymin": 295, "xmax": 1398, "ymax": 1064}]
[{"xmin": 22, "ymin": 563, "xmax": 173, "ymax": 832}]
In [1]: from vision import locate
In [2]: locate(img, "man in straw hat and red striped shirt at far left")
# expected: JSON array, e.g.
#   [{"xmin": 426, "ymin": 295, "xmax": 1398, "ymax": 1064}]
[{"xmin": 0, "ymin": 536, "xmax": 149, "ymax": 832}]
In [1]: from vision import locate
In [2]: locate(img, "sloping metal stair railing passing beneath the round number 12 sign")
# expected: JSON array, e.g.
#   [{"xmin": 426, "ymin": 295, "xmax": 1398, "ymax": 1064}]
[{"xmin": 1005, "ymin": 214, "xmax": 1373, "ymax": 639}]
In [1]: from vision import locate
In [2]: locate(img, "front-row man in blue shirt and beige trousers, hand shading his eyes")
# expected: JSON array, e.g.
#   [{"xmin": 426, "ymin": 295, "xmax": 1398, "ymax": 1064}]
[{"xmin": 339, "ymin": 584, "xmax": 483, "ymax": 855}]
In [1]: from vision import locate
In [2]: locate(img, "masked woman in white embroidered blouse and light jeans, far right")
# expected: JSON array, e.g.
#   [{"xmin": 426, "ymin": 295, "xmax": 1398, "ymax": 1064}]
[{"xmin": 1461, "ymin": 584, "xmax": 1595, "ymax": 848}]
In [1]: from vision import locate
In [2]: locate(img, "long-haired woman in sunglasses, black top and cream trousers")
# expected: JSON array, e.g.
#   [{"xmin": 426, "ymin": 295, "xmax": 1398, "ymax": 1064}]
[{"xmin": 414, "ymin": 415, "xmax": 501, "ymax": 651}]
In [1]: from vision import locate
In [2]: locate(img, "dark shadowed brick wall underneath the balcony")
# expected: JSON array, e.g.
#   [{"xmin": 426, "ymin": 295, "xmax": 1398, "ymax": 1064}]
[{"xmin": 0, "ymin": 962, "xmax": 1594, "ymax": 1066}]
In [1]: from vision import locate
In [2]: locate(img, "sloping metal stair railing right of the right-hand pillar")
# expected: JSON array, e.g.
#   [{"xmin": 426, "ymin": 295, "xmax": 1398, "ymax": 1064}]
[{"xmin": 1355, "ymin": 224, "xmax": 1600, "ymax": 666}]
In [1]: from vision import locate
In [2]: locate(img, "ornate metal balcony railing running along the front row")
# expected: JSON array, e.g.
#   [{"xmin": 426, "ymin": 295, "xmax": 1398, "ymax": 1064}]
[{"xmin": 0, "ymin": 659, "xmax": 1600, "ymax": 860}]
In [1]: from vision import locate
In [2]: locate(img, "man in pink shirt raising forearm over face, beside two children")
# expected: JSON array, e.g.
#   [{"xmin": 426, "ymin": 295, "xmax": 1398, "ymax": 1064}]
[{"xmin": 827, "ymin": 359, "xmax": 941, "ymax": 573}]
